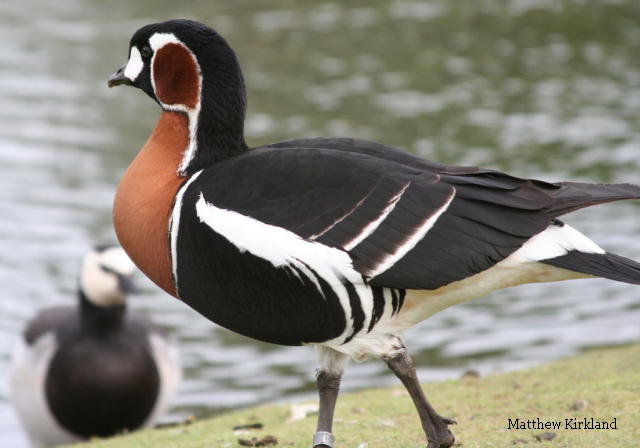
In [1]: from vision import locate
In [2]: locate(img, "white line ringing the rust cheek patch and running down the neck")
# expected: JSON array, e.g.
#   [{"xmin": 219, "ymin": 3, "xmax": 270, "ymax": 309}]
[{"xmin": 149, "ymin": 33, "xmax": 202, "ymax": 176}]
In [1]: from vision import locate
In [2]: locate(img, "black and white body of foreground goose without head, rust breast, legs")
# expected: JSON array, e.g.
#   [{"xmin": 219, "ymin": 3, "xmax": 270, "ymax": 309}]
[{"xmin": 170, "ymin": 138, "xmax": 640, "ymax": 359}]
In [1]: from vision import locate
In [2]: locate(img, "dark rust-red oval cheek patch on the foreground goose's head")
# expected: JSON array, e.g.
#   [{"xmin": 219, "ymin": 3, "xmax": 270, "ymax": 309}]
[{"xmin": 153, "ymin": 42, "xmax": 201, "ymax": 109}]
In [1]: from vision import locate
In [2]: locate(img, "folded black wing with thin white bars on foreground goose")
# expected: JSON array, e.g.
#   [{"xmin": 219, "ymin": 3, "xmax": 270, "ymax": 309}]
[{"xmin": 190, "ymin": 138, "xmax": 637, "ymax": 289}]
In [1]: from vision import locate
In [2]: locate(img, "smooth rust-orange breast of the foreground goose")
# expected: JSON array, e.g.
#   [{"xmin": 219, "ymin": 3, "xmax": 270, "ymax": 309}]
[{"xmin": 113, "ymin": 112, "xmax": 189, "ymax": 297}]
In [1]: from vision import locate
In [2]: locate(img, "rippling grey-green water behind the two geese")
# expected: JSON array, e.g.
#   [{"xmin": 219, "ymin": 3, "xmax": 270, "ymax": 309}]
[{"xmin": 0, "ymin": 0, "xmax": 640, "ymax": 447}]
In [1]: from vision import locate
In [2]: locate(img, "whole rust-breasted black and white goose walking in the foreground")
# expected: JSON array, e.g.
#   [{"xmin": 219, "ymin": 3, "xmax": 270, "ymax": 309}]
[{"xmin": 109, "ymin": 20, "xmax": 640, "ymax": 448}]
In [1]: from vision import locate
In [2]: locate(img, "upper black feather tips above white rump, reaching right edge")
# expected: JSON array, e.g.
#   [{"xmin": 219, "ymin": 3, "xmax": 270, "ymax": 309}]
[{"xmin": 547, "ymin": 182, "xmax": 640, "ymax": 218}]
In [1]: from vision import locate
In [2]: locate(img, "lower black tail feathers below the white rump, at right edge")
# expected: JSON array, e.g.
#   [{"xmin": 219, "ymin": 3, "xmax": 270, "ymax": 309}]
[{"xmin": 540, "ymin": 250, "xmax": 640, "ymax": 285}]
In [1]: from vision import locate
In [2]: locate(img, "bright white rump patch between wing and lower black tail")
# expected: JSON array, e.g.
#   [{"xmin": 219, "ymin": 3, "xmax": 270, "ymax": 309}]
[{"xmin": 509, "ymin": 224, "xmax": 605, "ymax": 263}]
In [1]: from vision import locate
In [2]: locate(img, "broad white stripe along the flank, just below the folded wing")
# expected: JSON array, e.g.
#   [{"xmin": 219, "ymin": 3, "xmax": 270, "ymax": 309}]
[{"xmin": 196, "ymin": 195, "xmax": 362, "ymax": 298}]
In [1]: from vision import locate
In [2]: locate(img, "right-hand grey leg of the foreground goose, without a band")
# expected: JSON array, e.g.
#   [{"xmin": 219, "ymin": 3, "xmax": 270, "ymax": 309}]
[{"xmin": 386, "ymin": 350, "xmax": 456, "ymax": 448}]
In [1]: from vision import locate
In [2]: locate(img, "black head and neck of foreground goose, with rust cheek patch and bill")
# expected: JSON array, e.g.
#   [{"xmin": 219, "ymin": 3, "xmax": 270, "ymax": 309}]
[{"xmin": 109, "ymin": 20, "xmax": 247, "ymax": 175}]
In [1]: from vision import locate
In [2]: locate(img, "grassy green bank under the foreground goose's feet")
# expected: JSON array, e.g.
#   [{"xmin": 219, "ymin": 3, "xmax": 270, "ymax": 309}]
[{"xmin": 76, "ymin": 345, "xmax": 640, "ymax": 448}]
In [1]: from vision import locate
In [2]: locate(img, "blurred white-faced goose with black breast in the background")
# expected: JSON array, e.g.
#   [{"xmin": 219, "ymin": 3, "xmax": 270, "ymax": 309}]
[{"xmin": 10, "ymin": 246, "xmax": 181, "ymax": 447}]
